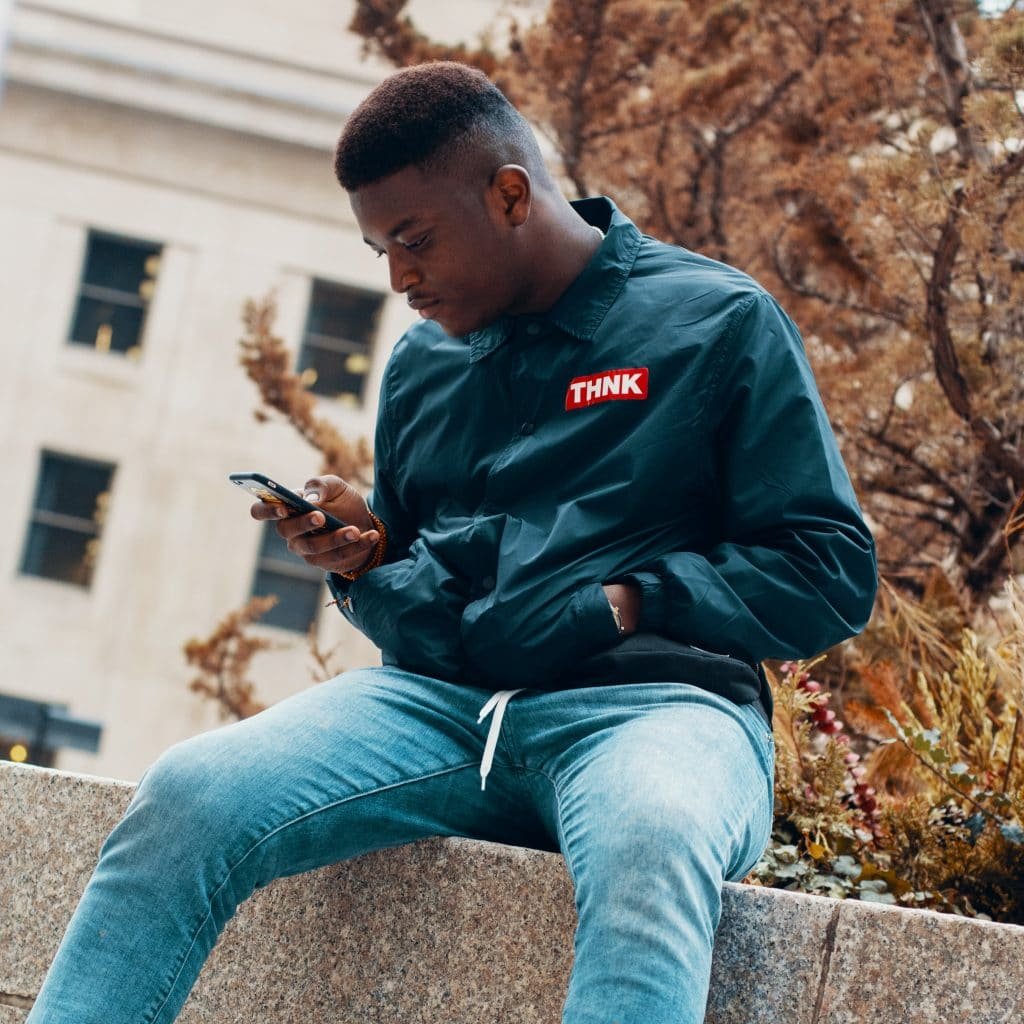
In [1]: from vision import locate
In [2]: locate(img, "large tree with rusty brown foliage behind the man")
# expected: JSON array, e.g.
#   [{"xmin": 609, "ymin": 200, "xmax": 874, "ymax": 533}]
[{"xmin": 351, "ymin": 0, "xmax": 1024, "ymax": 593}]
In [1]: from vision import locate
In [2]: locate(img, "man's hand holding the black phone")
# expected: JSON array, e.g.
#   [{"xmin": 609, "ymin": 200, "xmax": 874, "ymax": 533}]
[{"xmin": 249, "ymin": 476, "xmax": 380, "ymax": 572}]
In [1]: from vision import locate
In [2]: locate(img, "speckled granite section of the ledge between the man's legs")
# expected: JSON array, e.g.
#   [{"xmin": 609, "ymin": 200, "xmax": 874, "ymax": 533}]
[{"xmin": 181, "ymin": 840, "xmax": 574, "ymax": 1024}]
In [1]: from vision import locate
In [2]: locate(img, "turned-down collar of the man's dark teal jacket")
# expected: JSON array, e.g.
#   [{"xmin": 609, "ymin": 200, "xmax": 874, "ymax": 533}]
[{"xmin": 464, "ymin": 196, "xmax": 643, "ymax": 362}]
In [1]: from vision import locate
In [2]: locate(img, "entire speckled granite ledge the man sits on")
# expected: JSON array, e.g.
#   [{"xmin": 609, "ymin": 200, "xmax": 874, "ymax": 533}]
[{"xmin": 6, "ymin": 764, "xmax": 1024, "ymax": 1024}]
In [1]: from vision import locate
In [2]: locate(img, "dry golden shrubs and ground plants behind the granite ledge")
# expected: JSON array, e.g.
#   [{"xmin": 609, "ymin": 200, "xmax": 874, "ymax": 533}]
[{"xmin": 754, "ymin": 581, "xmax": 1024, "ymax": 924}]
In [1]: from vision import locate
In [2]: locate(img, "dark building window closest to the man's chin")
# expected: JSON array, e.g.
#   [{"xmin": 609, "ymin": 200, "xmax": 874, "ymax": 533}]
[{"xmin": 299, "ymin": 281, "xmax": 384, "ymax": 406}]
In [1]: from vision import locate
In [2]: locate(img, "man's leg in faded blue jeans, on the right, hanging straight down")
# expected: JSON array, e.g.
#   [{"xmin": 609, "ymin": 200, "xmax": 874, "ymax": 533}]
[{"xmin": 509, "ymin": 684, "xmax": 772, "ymax": 1024}]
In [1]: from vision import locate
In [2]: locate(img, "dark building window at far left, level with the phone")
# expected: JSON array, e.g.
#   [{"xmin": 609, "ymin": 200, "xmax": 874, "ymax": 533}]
[{"xmin": 22, "ymin": 452, "xmax": 114, "ymax": 587}]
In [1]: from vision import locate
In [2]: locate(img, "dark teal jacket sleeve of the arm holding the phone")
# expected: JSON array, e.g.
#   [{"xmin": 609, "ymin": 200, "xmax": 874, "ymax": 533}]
[{"xmin": 328, "ymin": 360, "xmax": 469, "ymax": 678}]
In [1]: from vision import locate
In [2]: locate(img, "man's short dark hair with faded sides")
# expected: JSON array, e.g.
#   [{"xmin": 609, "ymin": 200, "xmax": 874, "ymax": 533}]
[{"xmin": 334, "ymin": 60, "xmax": 550, "ymax": 191}]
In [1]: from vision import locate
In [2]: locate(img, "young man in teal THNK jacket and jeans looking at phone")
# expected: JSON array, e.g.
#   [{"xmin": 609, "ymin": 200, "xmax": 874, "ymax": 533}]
[{"xmin": 29, "ymin": 63, "xmax": 874, "ymax": 1024}]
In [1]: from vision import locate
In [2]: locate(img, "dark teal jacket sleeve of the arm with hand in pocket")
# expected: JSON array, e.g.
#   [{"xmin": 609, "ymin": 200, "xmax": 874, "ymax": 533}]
[{"xmin": 618, "ymin": 293, "xmax": 877, "ymax": 662}]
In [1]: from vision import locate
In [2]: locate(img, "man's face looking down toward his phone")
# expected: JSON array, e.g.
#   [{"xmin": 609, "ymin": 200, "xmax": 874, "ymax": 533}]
[{"xmin": 349, "ymin": 167, "xmax": 522, "ymax": 336}]
